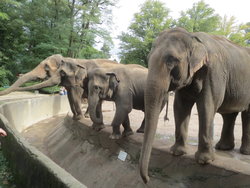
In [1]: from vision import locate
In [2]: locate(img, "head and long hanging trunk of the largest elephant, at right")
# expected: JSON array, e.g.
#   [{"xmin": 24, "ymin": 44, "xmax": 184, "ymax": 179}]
[{"xmin": 140, "ymin": 28, "xmax": 207, "ymax": 183}]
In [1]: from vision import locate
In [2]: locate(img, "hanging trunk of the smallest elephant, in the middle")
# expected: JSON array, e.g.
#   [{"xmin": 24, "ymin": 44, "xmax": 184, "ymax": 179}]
[{"xmin": 88, "ymin": 94, "xmax": 103, "ymax": 124}]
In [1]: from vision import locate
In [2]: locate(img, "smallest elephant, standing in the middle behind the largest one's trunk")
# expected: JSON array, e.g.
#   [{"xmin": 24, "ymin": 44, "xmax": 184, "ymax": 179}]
[{"xmin": 88, "ymin": 65, "xmax": 166, "ymax": 139}]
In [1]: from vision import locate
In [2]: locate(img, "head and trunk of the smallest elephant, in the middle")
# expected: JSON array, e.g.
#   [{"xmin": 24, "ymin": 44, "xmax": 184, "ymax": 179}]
[{"xmin": 88, "ymin": 68, "xmax": 120, "ymax": 124}]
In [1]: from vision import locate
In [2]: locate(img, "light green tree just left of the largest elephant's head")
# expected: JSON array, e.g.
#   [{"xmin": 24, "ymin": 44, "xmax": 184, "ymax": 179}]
[{"xmin": 119, "ymin": 0, "xmax": 172, "ymax": 66}]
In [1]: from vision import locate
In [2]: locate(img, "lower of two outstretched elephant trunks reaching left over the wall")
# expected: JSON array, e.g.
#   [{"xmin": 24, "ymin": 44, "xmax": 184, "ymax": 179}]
[{"xmin": 16, "ymin": 75, "xmax": 61, "ymax": 91}]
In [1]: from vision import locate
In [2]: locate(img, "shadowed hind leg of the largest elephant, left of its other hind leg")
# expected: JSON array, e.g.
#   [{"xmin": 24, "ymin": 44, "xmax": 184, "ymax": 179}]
[{"xmin": 215, "ymin": 112, "xmax": 238, "ymax": 150}]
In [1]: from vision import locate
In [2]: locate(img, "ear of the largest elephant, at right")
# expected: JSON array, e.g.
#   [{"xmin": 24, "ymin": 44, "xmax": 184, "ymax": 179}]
[{"xmin": 189, "ymin": 36, "xmax": 208, "ymax": 77}]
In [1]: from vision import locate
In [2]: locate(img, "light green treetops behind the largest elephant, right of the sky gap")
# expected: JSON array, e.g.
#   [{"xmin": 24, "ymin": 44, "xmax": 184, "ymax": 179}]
[{"xmin": 120, "ymin": 0, "xmax": 250, "ymax": 66}]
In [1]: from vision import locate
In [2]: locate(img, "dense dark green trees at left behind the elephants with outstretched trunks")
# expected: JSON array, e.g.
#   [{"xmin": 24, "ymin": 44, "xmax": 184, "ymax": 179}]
[{"xmin": 0, "ymin": 0, "xmax": 116, "ymax": 82}]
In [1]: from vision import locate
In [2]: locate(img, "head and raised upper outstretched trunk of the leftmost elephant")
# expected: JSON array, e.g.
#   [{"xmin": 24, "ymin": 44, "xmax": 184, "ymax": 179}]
[{"xmin": 0, "ymin": 54, "xmax": 63, "ymax": 95}]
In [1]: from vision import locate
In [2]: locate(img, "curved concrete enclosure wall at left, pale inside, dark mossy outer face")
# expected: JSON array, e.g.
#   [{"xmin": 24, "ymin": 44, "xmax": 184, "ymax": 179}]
[{"xmin": 0, "ymin": 96, "xmax": 86, "ymax": 188}]
